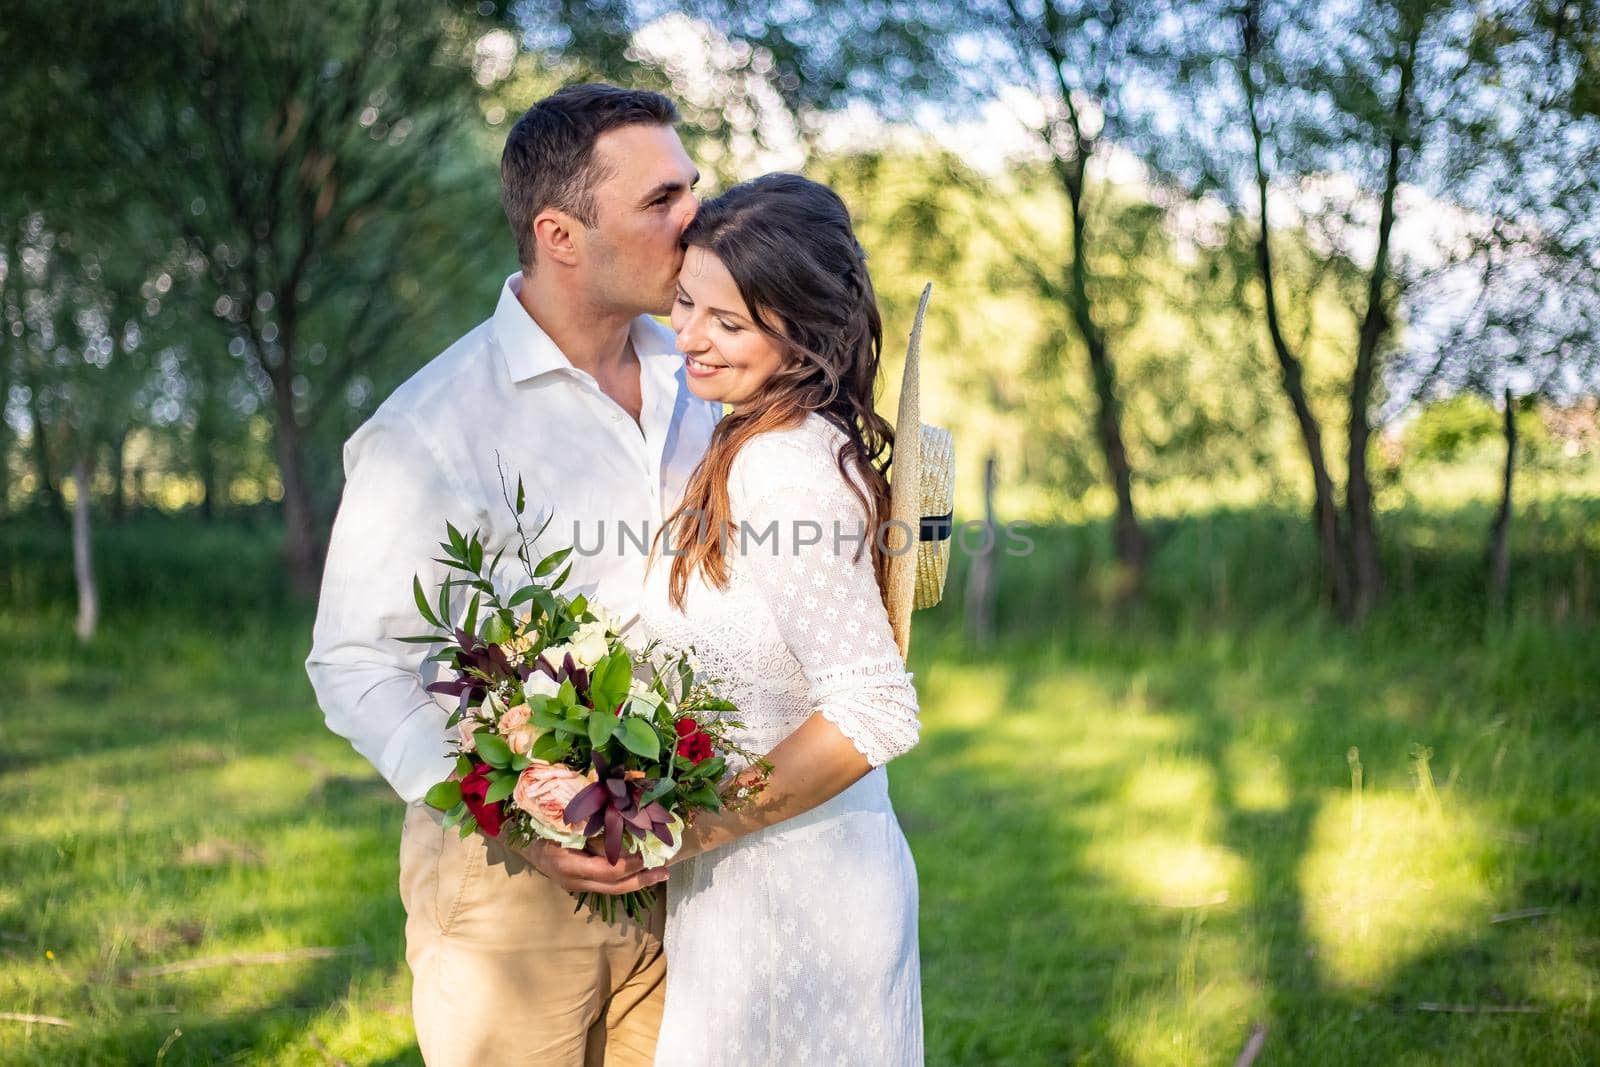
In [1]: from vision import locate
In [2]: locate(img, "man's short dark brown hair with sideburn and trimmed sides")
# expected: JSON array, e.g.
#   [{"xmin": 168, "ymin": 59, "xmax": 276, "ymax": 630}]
[{"xmin": 501, "ymin": 83, "xmax": 678, "ymax": 270}]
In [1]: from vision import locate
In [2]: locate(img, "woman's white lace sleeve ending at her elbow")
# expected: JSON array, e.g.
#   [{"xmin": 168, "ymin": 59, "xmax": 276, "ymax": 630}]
[{"xmin": 730, "ymin": 432, "xmax": 918, "ymax": 766}]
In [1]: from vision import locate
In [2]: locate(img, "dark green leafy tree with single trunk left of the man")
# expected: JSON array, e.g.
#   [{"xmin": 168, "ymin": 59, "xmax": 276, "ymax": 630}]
[{"xmin": 46, "ymin": 0, "xmax": 515, "ymax": 593}]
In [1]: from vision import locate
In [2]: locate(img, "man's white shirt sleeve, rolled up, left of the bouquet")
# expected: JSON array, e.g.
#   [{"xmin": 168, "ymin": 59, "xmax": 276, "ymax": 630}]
[{"xmin": 306, "ymin": 416, "xmax": 474, "ymax": 801}]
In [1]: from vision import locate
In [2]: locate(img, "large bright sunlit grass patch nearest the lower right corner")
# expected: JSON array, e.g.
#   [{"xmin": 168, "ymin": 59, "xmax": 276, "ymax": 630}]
[{"xmin": 1301, "ymin": 793, "xmax": 1493, "ymax": 987}]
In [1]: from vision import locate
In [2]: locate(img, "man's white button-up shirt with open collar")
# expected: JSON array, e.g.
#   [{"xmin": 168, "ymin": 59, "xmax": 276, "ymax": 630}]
[{"xmin": 306, "ymin": 274, "xmax": 718, "ymax": 801}]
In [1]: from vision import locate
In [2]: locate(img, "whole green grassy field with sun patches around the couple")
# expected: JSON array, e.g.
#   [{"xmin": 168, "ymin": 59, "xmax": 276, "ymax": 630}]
[{"xmin": 0, "ymin": 501, "xmax": 1600, "ymax": 1065}]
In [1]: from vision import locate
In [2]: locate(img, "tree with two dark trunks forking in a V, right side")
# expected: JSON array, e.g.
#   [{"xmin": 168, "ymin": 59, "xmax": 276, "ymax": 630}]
[{"xmin": 1154, "ymin": 0, "xmax": 1466, "ymax": 619}]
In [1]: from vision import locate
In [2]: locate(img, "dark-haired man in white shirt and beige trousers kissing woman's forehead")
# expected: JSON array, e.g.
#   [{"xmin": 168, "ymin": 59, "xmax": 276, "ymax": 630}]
[{"xmin": 306, "ymin": 85, "xmax": 715, "ymax": 1067}]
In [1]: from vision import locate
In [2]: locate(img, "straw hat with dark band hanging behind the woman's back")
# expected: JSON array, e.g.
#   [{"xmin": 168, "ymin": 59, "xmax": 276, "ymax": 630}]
[{"xmin": 885, "ymin": 282, "xmax": 955, "ymax": 656}]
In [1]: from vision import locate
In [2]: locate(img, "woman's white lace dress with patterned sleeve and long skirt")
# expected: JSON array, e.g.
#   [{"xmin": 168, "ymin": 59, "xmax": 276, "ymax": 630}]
[{"xmin": 642, "ymin": 416, "xmax": 923, "ymax": 1067}]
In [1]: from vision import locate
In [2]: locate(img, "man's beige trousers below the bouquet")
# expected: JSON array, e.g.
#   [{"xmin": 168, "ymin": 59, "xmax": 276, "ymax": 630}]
[{"xmin": 400, "ymin": 805, "xmax": 667, "ymax": 1067}]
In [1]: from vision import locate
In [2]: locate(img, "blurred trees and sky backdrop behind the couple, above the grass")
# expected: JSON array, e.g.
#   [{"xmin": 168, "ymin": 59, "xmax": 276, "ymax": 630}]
[{"xmin": 0, "ymin": 0, "xmax": 1600, "ymax": 633}]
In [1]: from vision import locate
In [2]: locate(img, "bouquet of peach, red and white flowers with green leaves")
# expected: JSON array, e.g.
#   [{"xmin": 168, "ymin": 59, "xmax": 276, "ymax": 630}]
[{"xmin": 403, "ymin": 480, "xmax": 770, "ymax": 921}]
